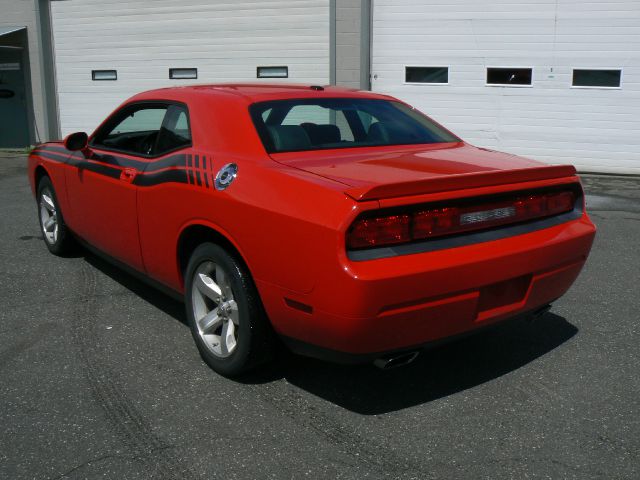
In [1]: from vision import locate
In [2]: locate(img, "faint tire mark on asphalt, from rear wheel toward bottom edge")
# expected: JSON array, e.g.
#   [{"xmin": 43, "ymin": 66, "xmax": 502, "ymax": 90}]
[{"xmin": 248, "ymin": 381, "xmax": 434, "ymax": 479}]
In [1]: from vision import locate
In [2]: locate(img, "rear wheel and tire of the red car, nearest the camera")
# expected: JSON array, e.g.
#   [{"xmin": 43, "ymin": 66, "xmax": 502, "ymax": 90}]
[{"xmin": 185, "ymin": 243, "xmax": 274, "ymax": 377}]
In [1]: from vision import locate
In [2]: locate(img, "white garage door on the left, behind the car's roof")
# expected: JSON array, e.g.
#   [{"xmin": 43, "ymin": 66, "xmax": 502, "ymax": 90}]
[{"xmin": 51, "ymin": 0, "xmax": 330, "ymax": 135}]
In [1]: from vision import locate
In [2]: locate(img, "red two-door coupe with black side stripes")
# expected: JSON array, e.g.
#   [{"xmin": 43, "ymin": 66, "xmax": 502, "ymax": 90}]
[{"xmin": 29, "ymin": 84, "xmax": 595, "ymax": 375}]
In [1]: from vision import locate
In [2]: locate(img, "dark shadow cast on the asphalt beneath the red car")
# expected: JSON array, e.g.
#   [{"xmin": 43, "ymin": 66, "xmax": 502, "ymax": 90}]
[{"xmin": 79, "ymin": 252, "xmax": 578, "ymax": 415}]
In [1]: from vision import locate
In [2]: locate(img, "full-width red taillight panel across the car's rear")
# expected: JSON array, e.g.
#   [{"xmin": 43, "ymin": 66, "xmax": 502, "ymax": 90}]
[{"xmin": 347, "ymin": 191, "xmax": 576, "ymax": 249}]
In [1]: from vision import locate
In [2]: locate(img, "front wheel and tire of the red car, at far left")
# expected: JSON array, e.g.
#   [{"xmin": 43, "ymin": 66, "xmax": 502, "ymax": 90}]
[{"xmin": 36, "ymin": 176, "xmax": 75, "ymax": 256}]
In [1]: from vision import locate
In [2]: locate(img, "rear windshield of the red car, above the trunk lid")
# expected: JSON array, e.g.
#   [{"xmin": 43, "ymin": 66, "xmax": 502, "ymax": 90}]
[{"xmin": 249, "ymin": 98, "xmax": 460, "ymax": 153}]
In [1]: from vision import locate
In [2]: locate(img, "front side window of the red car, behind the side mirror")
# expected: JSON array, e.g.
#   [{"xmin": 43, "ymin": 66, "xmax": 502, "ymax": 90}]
[{"xmin": 92, "ymin": 105, "xmax": 167, "ymax": 155}]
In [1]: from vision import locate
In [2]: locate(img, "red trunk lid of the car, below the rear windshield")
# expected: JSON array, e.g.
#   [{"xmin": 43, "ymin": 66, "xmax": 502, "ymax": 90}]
[{"xmin": 271, "ymin": 142, "xmax": 575, "ymax": 201}]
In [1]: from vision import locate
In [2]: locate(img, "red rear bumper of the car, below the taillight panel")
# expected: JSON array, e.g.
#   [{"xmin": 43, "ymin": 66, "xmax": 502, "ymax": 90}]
[{"xmin": 258, "ymin": 214, "xmax": 595, "ymax": 361}]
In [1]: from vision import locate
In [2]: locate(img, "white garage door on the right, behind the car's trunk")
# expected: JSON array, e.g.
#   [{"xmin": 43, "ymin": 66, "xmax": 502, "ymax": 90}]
[{"xmin": 372, "ymin": 0, "xmax": 640, "ymax": 173}]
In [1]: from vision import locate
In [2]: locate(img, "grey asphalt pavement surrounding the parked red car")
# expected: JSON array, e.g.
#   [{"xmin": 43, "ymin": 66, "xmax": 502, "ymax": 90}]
[{"xmin": 0, "ymin": 155, "xmax": 640, "ymax": 480}]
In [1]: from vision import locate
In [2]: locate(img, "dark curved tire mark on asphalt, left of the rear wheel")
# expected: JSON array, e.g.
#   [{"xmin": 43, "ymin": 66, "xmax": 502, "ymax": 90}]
[{"xmin": 70, "ymin": 262, "xmax": 195, "ymax": 480}]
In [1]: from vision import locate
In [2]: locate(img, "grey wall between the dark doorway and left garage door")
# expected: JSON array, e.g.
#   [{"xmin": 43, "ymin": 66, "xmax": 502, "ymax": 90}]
[{"xmin": 0, "ymin": 0, "xmax": 58, "ymax": 143}]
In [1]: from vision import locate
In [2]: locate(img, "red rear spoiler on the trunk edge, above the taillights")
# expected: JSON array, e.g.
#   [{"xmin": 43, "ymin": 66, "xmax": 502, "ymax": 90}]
[{"xmin": 344, "ymin": 165, "xmax": 576, "ymax": 202}]
